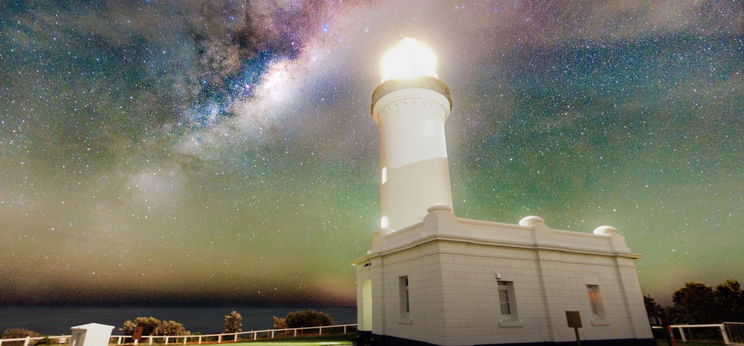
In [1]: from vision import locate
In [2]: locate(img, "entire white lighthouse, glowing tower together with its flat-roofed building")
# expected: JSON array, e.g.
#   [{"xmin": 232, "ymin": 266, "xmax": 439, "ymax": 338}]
[{"xmin": 354, "ymin": 39, "xmax": 656, "ymax": 345}]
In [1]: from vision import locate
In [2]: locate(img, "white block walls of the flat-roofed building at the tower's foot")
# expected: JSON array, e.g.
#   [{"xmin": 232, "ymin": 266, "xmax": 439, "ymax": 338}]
[{"xmin": 357, "ymin": 210, "xmax": 651, "ymax": 345}]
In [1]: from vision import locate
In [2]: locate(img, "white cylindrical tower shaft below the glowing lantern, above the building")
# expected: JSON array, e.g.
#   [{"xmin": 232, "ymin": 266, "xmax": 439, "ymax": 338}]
[{"xmin": 372, "ymin": 86, "xmax": 452, "ymax": 233}]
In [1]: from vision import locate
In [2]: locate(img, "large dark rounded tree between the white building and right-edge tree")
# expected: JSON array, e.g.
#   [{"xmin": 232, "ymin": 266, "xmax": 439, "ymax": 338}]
[{"xmin": 672, "ymin": 282, "xmax": 721, "ymax": 323}]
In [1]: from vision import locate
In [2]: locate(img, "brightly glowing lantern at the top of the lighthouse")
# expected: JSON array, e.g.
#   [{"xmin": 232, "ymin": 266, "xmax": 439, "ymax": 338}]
[{"xmin": 380, "ymin": 37, "xmax": 438, "ymax": 82}]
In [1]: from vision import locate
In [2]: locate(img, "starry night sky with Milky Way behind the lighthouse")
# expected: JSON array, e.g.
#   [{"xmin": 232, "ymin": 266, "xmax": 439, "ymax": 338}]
[{"xmin": 0, "ymin": 0, "xmax": 744, "ymax": 305}]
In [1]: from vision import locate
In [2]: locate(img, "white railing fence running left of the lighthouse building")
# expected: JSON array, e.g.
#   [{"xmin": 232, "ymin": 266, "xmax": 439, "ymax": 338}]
[{"xmin": 0, "ymin": 323, "xmax": 357, "ymax": 346}]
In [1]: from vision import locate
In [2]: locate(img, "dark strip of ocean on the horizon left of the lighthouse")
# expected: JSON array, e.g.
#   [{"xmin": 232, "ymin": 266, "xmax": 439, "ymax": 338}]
[{"xmin": 0, "ymin": 306, "xmax": 356, "ymax": 335}]
